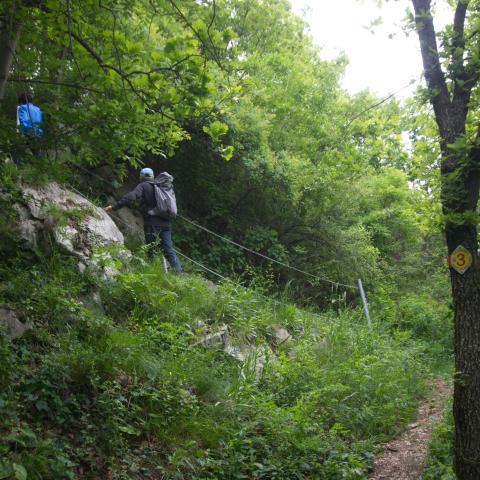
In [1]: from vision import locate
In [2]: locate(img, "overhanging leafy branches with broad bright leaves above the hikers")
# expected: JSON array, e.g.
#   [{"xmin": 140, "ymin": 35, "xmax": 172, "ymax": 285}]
[{"xmin": 1, "ymin": 0, "xmax": 232, "ymax": 165}]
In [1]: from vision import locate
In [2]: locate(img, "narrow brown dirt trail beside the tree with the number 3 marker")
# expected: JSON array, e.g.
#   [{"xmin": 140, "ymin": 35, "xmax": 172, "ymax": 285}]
[{"xmin": 369, "ymin": 379, "xmax": 451, "ymax": 480}]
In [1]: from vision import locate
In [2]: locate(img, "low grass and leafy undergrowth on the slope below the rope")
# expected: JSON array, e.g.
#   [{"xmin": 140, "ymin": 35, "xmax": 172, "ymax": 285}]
[{"xmin": 0, "ymin": 249, "xmax": 448, "ymax": 480}]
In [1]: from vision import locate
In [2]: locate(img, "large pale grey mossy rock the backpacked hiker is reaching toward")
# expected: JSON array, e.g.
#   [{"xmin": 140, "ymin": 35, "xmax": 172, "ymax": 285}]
[{"xmin": 15, "ymin": 183, "xmax": 130, "ymax": 277}]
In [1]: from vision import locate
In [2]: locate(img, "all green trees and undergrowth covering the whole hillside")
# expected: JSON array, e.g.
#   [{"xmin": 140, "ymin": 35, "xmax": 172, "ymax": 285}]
[{"xmin": 0, "ymin": 0, "xmax": 458, "ymax": 480}]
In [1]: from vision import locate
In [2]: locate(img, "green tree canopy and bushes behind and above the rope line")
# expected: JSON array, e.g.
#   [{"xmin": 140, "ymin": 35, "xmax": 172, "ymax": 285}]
[{"xmin": 0, "ymin": 0, "xmax": 448, "ymax": 304}]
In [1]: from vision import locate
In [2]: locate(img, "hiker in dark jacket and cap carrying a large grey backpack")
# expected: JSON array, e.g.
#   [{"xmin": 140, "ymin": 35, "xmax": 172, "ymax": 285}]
[{"xmin": 105, "ymin": 168, "xmax": 183, "ymax": 273}]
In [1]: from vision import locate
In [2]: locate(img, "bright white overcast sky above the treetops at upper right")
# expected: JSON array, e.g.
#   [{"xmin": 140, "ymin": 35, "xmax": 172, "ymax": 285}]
[{"xmin": 290, "ymin": 0, "xmax": 453, "ymax": 97}]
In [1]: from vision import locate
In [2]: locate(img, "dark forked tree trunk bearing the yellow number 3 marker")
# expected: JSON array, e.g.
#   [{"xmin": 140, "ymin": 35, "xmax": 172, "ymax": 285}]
[{"xmin": 412, "ymin": 0, "xmax": 480, "ymax": 480}]
